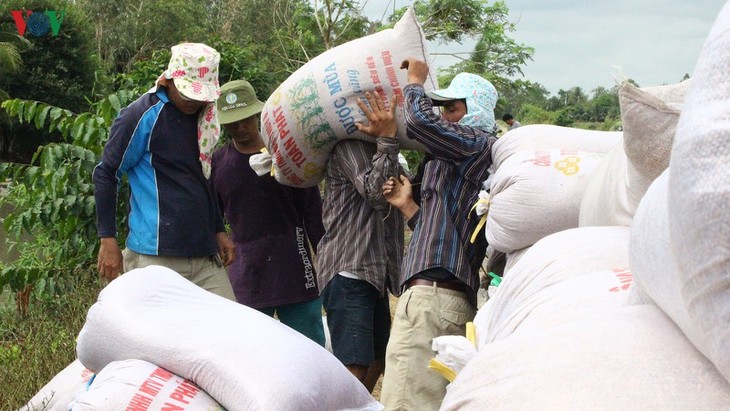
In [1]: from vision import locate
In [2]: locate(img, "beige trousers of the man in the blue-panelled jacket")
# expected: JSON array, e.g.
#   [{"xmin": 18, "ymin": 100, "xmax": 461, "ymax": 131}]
[{"xmin": 122, "ymin": 248, "xmax": 236, "ymax": 301}]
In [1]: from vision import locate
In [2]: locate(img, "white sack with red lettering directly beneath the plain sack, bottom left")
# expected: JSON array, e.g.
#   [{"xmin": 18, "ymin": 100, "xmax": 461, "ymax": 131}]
[{"xmin": 72, "ymin": 360, "xmax": 224, "ymax": 411}]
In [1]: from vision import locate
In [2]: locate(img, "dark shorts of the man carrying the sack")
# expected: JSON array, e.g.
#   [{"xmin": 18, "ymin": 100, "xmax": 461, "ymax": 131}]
[{"xmin": 322, "ymin": 275, "xmax": 390, "ymax": 366}]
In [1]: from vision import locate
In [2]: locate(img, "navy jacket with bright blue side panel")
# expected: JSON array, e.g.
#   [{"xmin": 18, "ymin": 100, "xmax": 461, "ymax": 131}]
[{"xmin": 93, "ymin": 88, "xmax": 225, "ymax": 257}]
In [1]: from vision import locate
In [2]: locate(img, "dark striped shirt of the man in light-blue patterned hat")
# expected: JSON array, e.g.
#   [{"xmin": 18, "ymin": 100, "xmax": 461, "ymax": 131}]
[{"xmin": 400, "ymin": 84, "xmax": 496, "ymax": 302}]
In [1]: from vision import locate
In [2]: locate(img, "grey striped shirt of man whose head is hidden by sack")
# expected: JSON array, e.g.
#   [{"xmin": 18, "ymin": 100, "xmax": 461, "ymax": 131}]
[{"xmin": 317, "ymin": 138, "xmax": 403, "ymax": 294}]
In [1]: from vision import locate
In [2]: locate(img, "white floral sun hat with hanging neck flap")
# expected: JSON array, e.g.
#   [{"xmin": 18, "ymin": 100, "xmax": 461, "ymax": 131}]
[{"xmin": 149, "ymin": 43, "xmax": 221, "ymax": 178}]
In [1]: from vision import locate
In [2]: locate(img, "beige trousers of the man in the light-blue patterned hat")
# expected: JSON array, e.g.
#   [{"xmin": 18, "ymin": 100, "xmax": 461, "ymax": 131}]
[{"xmin": 380, "ymin": 285, "xmax": 476, "ymax": 411}]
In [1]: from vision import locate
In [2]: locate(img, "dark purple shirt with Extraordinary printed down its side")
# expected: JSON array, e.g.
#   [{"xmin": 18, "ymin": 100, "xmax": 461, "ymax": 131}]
[{"xmin": 210, "ymin": 143, "xmax": 324, "ymax": 308}]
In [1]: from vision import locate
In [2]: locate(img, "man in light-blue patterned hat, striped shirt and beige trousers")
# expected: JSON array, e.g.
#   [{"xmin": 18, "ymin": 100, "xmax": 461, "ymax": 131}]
[{"xmin": 380, "ymin": 60, "xmax": 497, "ymax": 411}]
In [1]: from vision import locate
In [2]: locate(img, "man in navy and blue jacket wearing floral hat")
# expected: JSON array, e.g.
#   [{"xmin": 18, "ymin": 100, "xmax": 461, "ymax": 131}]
[{"xmin": 93, "ymin": 43, "xmax": 235, "ymax": 300}]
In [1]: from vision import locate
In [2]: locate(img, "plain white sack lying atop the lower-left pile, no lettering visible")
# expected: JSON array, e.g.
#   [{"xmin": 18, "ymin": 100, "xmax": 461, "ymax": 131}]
[{"xmin": 76, "ymin": 266, "xmax": 382, "ymax": 411}]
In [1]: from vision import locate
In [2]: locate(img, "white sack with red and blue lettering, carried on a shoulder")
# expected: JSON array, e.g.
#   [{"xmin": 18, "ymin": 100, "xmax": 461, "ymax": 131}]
[{"xmin": 261, "ymin": 8, "xmax": 437, "ymax": 187}]
